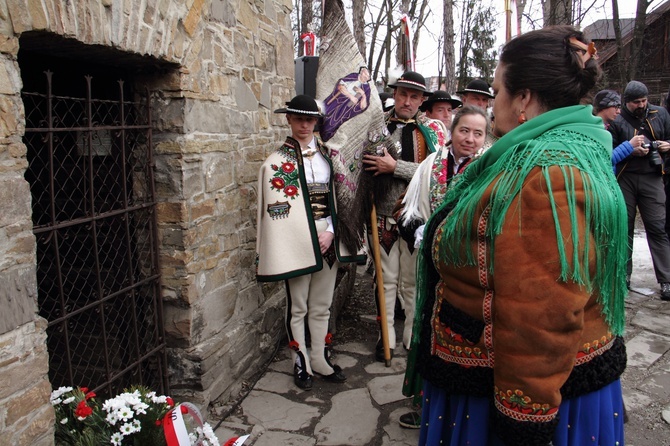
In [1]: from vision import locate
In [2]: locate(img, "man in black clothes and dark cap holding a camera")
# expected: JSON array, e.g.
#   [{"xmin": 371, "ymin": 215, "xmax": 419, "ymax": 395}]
[{"xmin": 609, "ymin": 81, "xmax": 670, "ymax": 300}]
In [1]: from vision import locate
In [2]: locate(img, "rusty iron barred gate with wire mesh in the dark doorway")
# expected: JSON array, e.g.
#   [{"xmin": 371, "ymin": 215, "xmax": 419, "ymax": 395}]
[{"xmin": 22, "ymin": 71, "xmax": 169, "ymax": 396}]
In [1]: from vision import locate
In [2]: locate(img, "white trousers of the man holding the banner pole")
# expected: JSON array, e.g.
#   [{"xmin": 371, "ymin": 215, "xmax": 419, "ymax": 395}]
[{"xmin": 368, "ymin": 217, "xmax": 418, "ymax": 348}]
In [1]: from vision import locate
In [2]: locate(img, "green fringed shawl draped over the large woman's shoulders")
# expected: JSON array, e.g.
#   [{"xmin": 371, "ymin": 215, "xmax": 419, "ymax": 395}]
[{"xmin": 403, "ymin": 105, "xmax": 628, "ymax": 400}]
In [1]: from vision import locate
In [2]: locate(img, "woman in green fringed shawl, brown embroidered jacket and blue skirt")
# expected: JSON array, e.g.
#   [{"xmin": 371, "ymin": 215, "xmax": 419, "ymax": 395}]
[{"xmin": 405, "ymin": 26, "xmax": 627, "ymax": 446}]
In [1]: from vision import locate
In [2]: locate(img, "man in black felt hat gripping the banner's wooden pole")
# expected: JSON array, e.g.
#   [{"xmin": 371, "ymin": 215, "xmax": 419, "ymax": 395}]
[{"xmin": 363, "ymin": 71, "xmax": 446, "ymax": 362}]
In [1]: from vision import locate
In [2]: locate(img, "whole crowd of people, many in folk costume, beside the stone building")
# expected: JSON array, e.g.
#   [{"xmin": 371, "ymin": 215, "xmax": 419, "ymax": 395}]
[{"xmin": 257, "ymin": 26, "xmax": 670, "ymax": 446}]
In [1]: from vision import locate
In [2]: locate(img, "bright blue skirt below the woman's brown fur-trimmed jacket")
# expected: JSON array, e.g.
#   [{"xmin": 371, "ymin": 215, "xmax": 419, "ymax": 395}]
[{"xmin": 419, "ymin": 379, "xmax": 624, "ymax": 446}]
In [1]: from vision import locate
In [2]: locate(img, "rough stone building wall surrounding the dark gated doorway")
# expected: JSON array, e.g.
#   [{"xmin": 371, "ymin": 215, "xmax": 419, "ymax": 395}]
[{"xmin": 0, "ymin": 0, "xmax": 294, "ymax": 445}]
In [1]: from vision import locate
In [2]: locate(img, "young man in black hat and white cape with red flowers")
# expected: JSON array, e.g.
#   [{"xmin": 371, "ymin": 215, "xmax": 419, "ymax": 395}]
[{"xmin": 256, "ymin": 95, "xmax": 363, "ymax": 390}]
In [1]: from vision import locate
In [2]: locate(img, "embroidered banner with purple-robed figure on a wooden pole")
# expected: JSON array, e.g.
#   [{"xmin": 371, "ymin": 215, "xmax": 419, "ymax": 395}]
[{"xmin": 316, "ymin": 0, "xmax": 391, "ymax": 367}]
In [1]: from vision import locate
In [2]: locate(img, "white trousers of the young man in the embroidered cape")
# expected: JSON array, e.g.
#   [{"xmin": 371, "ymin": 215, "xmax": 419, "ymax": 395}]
[{"xmin": 286, "ymin": 221, "xmax": 339, "ymax": 375}]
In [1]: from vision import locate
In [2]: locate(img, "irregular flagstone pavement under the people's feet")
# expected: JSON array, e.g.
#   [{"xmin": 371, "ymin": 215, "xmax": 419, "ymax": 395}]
[{"xmin": 214, "ymin": 233, "xmax": 670, "ymax": 446}]
